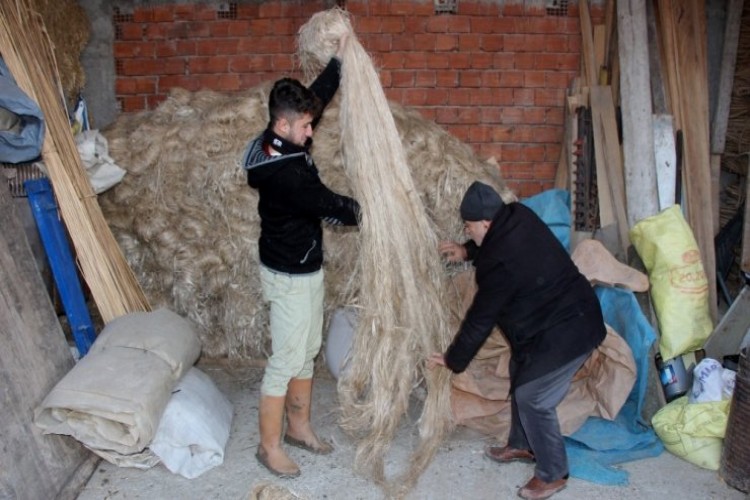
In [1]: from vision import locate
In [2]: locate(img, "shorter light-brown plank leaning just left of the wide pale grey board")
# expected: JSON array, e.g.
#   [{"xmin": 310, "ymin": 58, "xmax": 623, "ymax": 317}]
[{"xmin": 589, "ymin": 86, "xmax": 630, "ymax": 259}]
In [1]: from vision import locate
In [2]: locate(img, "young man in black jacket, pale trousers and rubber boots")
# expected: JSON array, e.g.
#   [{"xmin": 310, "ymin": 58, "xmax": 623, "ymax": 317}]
[{"xmin": 243, "ymin": 35, "xmax": 359, "ymax": 477}]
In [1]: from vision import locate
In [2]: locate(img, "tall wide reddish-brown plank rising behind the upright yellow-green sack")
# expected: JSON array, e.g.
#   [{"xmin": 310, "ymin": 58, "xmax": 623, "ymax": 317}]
[{"xmin": 658, "ymin": 0, "xmax": 718, "ymax": 321}]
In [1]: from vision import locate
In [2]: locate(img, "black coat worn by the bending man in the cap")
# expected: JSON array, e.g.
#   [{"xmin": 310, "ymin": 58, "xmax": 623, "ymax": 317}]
[{"xmin": 445, "ymin": 203, "xmax": 606, "ymax": 388}]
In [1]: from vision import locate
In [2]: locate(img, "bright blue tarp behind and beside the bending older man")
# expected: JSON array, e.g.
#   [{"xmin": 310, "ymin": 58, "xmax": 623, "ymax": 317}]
[{"xmin": 522, "ymin": 189, "xmax": 664, "ymax": 485}]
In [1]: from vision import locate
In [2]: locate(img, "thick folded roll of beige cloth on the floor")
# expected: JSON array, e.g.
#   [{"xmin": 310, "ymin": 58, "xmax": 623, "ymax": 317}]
[{"xmin": 34, "ymin": 309, "xmax": 201, "ymax": 468}]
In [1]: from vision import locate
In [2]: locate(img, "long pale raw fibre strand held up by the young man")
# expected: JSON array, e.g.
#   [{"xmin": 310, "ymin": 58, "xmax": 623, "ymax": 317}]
[{"xmin": 299, "ymin": 8, "xmax": 452, "ymax": 497}]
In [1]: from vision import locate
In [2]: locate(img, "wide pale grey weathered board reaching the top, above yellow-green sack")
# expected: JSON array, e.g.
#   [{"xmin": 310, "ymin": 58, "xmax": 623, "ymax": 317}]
[{"xmin": 617, "ymin": 0, "xmax": 659, "ymax": 227}]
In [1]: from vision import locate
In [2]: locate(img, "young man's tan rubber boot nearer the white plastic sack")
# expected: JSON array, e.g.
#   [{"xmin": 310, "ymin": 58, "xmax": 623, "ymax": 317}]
[{"xmin": 255, "ymin": 396, "xmax": 300, "ymax": 478}]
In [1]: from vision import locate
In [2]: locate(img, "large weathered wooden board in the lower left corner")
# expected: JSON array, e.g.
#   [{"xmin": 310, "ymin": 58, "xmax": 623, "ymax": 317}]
[{"xmin": 0, "ymin": 189, "xmax": 98, "ymax": 499}]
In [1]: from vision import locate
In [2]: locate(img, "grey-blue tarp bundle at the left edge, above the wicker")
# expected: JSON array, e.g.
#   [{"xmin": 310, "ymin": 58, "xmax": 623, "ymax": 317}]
[{"xmin": 0, "ymin": 59, "xmax": 44, "ymax": 163}]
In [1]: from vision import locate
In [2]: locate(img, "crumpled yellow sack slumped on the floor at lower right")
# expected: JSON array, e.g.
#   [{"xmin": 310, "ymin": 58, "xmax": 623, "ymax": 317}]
[{"xmin": 651, "ymin": 396, "xmax": 730, "ymax": 470}]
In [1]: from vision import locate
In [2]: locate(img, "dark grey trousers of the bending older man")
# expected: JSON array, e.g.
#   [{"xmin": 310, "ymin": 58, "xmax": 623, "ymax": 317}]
[{"xmin": 508, "ymin": 353, "xmax": 590, "ymax": 483}]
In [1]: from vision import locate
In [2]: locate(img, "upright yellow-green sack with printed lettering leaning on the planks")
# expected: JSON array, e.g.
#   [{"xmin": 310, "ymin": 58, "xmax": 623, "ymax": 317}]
[{"xmin": 630, "ymin": 205, "xmax": 713, "ymax": 359}]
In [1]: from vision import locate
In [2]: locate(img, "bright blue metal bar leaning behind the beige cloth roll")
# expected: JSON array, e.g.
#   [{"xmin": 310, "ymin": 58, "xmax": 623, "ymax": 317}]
[{"xmin": 24, "ymin": 178, "xmax": 96, "ymax": 357}]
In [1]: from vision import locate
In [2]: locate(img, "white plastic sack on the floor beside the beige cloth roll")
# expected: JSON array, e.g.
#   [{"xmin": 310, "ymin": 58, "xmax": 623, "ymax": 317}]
[{"xmin": 149, "ymin": 367, "xmax": 232, "ymax": 479}]
